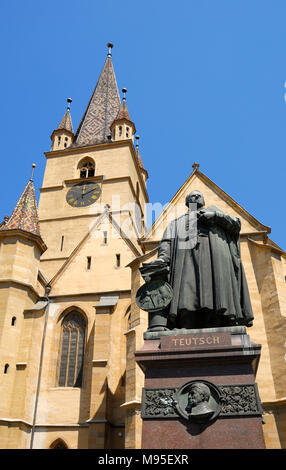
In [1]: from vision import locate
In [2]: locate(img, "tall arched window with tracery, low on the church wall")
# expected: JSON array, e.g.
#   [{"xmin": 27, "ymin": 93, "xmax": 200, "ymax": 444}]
[{"xmin": 58, "ymin": 311, "xmax": 86, "ymax": 387}]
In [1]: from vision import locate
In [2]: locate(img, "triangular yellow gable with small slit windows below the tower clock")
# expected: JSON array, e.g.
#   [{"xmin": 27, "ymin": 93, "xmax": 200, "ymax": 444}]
[{"xmin": 50, "ymin": 212, "xmax": 140, "ymax": 295}]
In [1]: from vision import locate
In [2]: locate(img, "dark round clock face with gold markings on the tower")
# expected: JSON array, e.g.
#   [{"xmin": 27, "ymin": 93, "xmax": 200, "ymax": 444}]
[{"xmin": 66, "ymin": 181, "xmax": 101, "ymax": 207}]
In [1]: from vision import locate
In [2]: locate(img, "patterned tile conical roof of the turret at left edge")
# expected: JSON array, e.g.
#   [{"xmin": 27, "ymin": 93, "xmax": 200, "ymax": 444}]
[{"xmin": 0, "ymin": 174, "xmax": 41, "ymax": 236}]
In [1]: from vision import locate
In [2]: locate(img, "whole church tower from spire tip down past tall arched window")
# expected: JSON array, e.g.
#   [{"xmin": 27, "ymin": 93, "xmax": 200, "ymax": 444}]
[{"xmin": 18, "ymin": 43, "xmax": 148, "ymax": 449}]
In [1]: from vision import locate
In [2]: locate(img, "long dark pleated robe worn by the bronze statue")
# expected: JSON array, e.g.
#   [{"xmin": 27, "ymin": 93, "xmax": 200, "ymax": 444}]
[{"xmin": 158, "ymin": 206, "xmax": 253, "ymax": 325}]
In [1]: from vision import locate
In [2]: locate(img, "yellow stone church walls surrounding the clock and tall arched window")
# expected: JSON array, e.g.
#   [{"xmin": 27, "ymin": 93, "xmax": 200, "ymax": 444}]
[{"xmin": 0, "ymin": 46, "xmax": 286, "ymax": 449}]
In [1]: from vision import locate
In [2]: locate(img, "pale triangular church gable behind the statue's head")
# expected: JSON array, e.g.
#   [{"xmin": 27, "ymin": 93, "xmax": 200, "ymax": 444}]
[{"xmin": 143, "ymin": 167, "xmax": 270, "ymax": 243}]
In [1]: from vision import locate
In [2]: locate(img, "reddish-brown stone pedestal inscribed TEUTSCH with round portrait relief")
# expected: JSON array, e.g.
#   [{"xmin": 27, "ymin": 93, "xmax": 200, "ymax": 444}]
[{"xmin": 135, "ymin": 327, "xmax": 265, "ymax": 449}]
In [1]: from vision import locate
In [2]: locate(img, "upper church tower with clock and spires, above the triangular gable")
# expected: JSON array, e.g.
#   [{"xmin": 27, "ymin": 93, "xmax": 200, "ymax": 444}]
[{"xmin": 39, "ymin": 43, "xmax": 148, "ymax": 283}]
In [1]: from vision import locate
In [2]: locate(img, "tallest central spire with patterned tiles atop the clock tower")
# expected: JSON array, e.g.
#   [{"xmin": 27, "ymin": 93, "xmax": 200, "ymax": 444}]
[{"xmin": 73, "ymin": 43, "xmax": 120, "ymax": 146}]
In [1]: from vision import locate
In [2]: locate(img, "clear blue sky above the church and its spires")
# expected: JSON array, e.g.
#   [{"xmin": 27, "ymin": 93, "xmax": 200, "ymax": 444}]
[{"xmin": 0, "ymin": 0, "xmax": 286, "ymax": 249}]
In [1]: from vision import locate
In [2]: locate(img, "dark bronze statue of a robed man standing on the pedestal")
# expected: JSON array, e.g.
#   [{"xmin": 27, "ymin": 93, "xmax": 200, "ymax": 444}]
[{"xmin": 140, "ymin": 190, "xmax": 253, "ymax": 330}]
